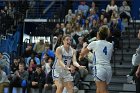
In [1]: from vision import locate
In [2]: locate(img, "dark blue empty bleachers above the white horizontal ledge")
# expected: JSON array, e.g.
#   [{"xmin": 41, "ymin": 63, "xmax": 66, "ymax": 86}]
[{"xmin": 26, "ymin": 0, "xmax": 67, "ymax": 19}]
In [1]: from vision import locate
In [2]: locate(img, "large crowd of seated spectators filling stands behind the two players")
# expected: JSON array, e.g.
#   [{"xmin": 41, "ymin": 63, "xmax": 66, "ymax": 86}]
[{"xmin": 0, "ymin": 0, "xmax": 131, "ymax": 93}]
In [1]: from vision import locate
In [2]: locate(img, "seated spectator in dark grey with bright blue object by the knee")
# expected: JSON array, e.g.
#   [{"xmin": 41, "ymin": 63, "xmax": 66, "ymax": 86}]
[{"xmin": 9, "ymin": 63, "xmax": 29, "ymax": 93}]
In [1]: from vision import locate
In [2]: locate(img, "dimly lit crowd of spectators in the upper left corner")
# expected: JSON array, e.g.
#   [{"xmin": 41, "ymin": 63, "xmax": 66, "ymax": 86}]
[{"xmin": 0, "ymin": 0, "xmax": 28, "ymax": 38}]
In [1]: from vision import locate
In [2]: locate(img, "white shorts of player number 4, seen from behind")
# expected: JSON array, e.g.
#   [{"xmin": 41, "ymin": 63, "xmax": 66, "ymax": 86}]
[{"xmin": 93, "ymin": 65, "xmax": 112, "ymax": 84}]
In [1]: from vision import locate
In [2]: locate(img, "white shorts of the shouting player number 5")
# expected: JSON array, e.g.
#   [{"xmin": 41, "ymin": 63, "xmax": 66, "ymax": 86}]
[{"xmin": 52, "ymin": 68, "xmax": 73, "ymax": 82}]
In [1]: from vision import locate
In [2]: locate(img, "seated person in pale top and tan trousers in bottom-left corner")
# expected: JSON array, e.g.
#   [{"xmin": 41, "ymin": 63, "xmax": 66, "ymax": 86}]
[{"xmin": 0, "ymin": 65, "xmax": 9, "ymax": 93}]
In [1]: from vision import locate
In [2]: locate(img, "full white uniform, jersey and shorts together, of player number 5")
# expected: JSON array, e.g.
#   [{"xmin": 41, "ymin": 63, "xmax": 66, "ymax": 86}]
[{"xmin": 52, "ymin": 45, "xmax": 73, "ymax": 82}]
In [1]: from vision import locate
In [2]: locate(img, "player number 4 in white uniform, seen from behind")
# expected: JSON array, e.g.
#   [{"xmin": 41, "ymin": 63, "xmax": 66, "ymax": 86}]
[{"xmin": 79, "ymin": 27, "xmax": 113, "ymax": 93}]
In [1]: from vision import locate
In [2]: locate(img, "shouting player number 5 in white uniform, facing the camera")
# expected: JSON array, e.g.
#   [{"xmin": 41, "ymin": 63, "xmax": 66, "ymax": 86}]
[{"xmin": 52, "ymin": 36, "xmax": 85, "ymax": 93}]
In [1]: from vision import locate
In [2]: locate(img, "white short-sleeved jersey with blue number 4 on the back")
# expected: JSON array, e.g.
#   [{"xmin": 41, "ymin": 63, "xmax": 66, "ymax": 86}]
[{"xmin": 87, "ymin": 40, "xmax": 113, "ymax": 66}]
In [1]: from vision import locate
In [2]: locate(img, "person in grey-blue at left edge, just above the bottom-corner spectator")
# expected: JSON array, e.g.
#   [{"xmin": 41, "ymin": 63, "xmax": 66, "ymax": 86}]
[{"xmin": 0, "ymin": 52, "xmax": 10, "ymax": 75}]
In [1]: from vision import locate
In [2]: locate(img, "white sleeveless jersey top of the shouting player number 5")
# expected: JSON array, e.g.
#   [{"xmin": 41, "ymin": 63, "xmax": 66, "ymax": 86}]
[{"xmin": 53, "ymin": 45, "xmax": 73, "ymax": 69}]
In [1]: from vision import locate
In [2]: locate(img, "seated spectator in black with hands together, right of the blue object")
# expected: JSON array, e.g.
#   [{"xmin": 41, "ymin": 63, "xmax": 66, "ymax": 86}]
[{"xmin": 30, "ymin": 65, "xmax": 46, "ymax": 93}]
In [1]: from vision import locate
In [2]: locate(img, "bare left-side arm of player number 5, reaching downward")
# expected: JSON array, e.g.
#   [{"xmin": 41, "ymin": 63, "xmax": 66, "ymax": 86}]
[{"xmin": 55, "ymin": 47, "xmax": 68, "ymax": 69}]
